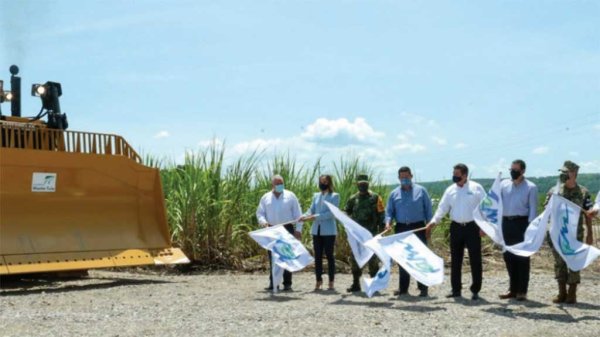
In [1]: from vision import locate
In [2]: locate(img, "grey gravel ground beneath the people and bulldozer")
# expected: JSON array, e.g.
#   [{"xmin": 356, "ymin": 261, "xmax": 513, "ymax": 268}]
[{"xmin": 0, "ymin": 270, "xmax": 600, "ymax": 337}]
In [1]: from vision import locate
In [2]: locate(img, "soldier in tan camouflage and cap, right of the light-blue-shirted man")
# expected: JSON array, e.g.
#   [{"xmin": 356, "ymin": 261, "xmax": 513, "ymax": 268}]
[{"xmin": 544, "ymin": 160, "xmax": 593, "ymax": 304}]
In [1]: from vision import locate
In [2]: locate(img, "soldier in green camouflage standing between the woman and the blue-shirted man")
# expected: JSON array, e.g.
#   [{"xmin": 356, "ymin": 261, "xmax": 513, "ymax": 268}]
[{"xmin": 345, "ymin": 174, "xmax": 384, "ymax": 292}]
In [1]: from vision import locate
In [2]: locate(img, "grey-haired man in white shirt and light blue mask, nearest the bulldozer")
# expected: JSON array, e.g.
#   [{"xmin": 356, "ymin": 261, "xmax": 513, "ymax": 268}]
[{"xmin": 256, "ymin": 175, "xmax": 302, "ymax": 291}]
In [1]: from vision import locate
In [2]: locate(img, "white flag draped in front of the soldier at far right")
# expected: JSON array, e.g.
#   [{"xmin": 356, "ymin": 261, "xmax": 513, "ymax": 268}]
[{"xmin": 550, "ymin": 194, "xmax": 600, "ymax": 271}]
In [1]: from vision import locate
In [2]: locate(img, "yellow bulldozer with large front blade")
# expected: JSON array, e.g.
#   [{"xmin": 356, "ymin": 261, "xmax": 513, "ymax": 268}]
[{"xmin": 0, "ymin": 66, "xmax": 189, "ymax": 275}]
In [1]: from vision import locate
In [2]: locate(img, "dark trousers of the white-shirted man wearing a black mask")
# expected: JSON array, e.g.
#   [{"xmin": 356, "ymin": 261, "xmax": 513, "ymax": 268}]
[{"xmin": 450, "ymin": 221, "xmax": 483, "ymax": 294}]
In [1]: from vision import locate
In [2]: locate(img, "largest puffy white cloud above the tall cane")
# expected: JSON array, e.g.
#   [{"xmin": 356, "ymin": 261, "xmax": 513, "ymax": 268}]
[{"xmin": 301, "ymin": 117, "xmax": 385, "ymax": 145}]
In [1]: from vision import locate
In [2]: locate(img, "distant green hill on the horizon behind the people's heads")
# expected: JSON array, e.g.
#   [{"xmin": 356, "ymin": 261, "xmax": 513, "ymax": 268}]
[{"xmin": 406, "ymin": 173, "xmax": 600, "ymax": 198}]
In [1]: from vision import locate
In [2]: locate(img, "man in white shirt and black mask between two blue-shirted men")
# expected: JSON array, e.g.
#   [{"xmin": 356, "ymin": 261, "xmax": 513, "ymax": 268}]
[{"xmin": 427, "ymin": 164, "xmax": 486, "ymax": 300}]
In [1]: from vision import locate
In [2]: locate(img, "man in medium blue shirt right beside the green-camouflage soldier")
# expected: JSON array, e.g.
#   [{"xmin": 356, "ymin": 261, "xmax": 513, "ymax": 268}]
[{"xmin": 385, "ymin": 166, "xmax": 432, "ymax": 297}]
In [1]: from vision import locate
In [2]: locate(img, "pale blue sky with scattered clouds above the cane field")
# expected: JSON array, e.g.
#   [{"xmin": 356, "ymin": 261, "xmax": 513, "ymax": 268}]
[{"xmin": 0, "ymin": 0, "xmax": 600, "ymax": 182}]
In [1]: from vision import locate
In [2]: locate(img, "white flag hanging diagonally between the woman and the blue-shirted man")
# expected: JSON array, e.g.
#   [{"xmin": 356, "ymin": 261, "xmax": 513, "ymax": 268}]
[{"xmin": 325, "ymin": 201, "xmax": 373, "ymax": 268}]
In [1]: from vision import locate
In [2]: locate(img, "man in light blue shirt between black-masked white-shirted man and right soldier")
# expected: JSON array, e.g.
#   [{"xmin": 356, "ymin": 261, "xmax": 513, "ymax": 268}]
[{"xmin": 499, "ymin": 159, "xmax": 538, "ymax": 301}]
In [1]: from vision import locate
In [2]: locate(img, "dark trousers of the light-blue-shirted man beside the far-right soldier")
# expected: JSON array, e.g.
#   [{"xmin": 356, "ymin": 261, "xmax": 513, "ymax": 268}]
[{"xmin": 502, "ymin": 216, "xmax": 531, "ymax": 294}]
